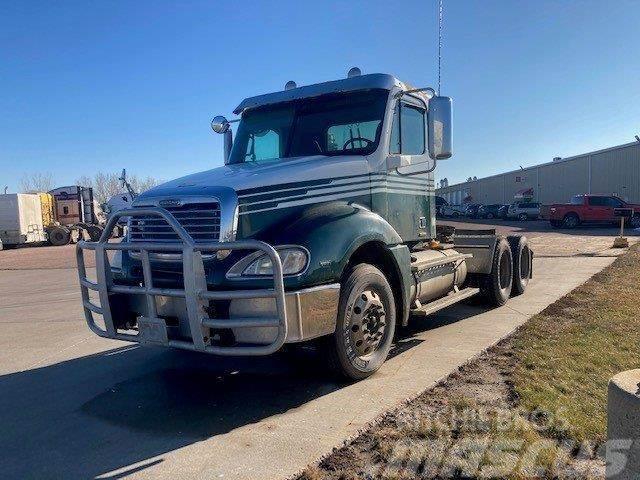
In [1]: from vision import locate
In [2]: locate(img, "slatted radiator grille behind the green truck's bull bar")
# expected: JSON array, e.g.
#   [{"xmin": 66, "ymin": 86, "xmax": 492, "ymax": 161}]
[{"xmin": 129, "ymin": 202, "xmax": 220, "ymax": 242}]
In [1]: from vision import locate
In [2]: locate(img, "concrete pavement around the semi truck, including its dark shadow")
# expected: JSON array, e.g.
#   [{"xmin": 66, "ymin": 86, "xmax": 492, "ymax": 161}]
[{"xmin": 0, "ymin": 222, "xmax": 637, "ymax": 479}]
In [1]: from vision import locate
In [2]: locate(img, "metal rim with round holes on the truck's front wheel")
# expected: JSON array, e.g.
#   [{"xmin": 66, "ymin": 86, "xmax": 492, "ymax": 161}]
[{"xmin": 350, "ymin": 290, "xmax": 387, "ymax": 357}]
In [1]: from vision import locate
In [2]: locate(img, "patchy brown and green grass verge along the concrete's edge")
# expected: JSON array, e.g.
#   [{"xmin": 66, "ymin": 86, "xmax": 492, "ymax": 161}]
[{"xmin": 299, "ymin": 244, "xmax": 640, "ymax": 480}]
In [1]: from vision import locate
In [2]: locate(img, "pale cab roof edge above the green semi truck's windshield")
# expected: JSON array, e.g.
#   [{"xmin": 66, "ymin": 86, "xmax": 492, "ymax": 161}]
[{"xmin": 233, "ymin": 73, "xmax": 411, "ymax": 115}]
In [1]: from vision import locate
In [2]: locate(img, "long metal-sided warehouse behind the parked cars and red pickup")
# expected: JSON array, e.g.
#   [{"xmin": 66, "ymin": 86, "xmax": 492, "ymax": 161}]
[{"xmin": 436, "ymin": 141, "xmax": 640, "ymax": 205}]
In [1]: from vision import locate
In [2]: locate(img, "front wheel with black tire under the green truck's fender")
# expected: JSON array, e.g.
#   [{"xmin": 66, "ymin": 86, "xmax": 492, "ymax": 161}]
[{"xmin": 326, "ymin": 263, "xmax": 396, "ymax": 380}]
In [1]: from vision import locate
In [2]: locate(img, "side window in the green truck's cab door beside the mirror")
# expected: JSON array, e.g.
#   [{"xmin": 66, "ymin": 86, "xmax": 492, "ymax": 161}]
[{"xmin": 389, "ymin": 102, "xmax": 425, "ymax": 155}]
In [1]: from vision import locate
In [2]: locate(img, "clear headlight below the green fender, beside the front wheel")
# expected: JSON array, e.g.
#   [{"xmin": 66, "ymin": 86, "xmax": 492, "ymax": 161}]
[{"xmin": 227, "ymin": 247, "xmax": 309, "ymax": 278}]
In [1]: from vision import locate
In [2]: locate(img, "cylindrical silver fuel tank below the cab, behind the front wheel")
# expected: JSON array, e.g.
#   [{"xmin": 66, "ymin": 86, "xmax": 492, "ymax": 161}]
[{"xmin": 411, "ymin": 249, "xmax": 470, "ymax": 303}]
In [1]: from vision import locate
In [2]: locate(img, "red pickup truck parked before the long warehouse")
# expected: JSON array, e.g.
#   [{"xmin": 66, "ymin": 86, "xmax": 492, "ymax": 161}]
[{"xmin": 540, "ymin": 195, "xmax": 640, "ymax": 228}]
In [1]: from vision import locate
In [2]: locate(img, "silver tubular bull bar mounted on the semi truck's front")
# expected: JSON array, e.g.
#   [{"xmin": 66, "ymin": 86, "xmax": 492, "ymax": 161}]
[{"xmin": 76, "ymin": 207, "xmax": 287, "ymax": 355}]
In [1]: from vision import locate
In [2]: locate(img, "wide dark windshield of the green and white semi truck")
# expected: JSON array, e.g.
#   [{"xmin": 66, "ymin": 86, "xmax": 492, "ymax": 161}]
[{"xmin": 229, "ymin": 90, "xmax": 389, "ymax": 164}]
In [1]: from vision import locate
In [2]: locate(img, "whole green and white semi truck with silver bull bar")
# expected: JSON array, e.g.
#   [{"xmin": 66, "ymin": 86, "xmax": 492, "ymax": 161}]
[{"xmin": 77, "ymin": 72, "xmax": 533, "ymax": 380}]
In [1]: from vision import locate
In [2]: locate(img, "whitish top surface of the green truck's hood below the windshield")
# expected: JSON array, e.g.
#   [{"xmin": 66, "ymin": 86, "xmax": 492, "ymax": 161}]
[{"xmin": 135, "ymin": 155, "xmax": 367, "ymax": 199}]
